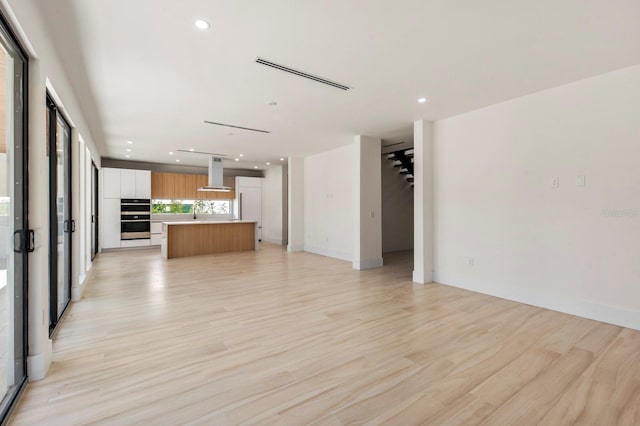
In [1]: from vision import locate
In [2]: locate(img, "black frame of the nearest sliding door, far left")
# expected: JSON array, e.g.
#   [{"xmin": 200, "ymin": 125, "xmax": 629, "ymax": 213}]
[{"xmin": 0, "ymin": 8, "xmax": 34, "ymax": 424}]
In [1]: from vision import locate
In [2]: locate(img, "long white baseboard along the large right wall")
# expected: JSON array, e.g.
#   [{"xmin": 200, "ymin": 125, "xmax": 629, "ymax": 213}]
[{"xmin": 434, "ymin": 275, "xmax": 640, "ymax": 330}]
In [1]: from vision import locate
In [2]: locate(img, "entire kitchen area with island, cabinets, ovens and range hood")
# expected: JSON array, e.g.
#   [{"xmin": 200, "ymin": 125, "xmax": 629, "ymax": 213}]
[{"xmin": 99, "ymin": 156, "xmax": 287, "ymax": 259}]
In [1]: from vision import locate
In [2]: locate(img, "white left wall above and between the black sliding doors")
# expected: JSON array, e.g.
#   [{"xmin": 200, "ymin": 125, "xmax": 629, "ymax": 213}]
[{"xmin": 0, "ymin": 0, "xmax": 101, "ymax": 380}]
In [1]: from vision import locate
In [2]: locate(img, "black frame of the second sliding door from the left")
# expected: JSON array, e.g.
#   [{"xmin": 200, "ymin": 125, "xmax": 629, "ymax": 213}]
[{"xmin": 47, "ymin": 91, "xmax": 75, "ymax": 337}]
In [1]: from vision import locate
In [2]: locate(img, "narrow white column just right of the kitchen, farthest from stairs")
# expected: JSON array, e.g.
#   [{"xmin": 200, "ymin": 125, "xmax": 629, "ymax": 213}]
[{"xmin": 287, "ymin": 157, "xmax": 304, "ymax": 251}]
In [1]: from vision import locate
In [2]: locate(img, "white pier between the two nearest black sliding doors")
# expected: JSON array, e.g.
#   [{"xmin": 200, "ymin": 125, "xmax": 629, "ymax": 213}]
[{"xmin": 27, "ymin": 60, "xmax": 53, "ymax": 381}]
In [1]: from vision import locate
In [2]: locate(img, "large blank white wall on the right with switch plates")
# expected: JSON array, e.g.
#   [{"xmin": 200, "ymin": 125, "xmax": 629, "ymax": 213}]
[{"xmin": 434, "ymin": 66, "xmax": 640, "ymax": 329}]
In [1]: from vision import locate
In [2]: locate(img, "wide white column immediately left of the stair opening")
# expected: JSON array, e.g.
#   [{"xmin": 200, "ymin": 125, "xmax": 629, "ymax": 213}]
[{"xmin": 353, "ymin": 136, "xmax": 382, "ymax": 270}]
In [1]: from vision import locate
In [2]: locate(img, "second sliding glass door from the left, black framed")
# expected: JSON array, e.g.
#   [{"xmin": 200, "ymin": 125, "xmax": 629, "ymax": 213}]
[{"xmin": 47, "ymin": 96, "xmax": 75, "ymax": 333}]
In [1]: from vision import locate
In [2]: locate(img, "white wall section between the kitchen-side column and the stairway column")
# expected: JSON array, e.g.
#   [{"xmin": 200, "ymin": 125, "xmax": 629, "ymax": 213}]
[{"xmin": 304, "ymin": 145, "xmax": 355, "ymax": 261}]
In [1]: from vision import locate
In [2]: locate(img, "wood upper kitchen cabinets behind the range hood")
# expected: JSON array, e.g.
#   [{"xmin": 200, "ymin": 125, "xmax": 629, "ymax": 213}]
[{"xmin": 151, "ymin": 172, "xmax": 236, "ymax": 200}]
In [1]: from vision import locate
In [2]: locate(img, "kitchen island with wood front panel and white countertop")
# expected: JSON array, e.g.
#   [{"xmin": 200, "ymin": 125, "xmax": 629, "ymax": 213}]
[{"xmin": 161, "ymin": 220, "xmax": 258, "ymax": 259}]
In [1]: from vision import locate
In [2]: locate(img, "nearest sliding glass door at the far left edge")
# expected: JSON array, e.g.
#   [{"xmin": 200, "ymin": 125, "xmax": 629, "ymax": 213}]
[{"xmin": 0, "ymin": 11, "xmax": 28, "ymax": 423}]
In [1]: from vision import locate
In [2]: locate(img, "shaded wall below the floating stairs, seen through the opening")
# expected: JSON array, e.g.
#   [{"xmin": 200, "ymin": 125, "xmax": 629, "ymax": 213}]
[{"xmin": 380, "ymin": 154, "xmax": 413, "ymax": 253}]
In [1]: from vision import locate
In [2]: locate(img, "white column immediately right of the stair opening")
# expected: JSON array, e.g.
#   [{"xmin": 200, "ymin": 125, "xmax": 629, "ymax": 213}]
[{"xmin": 413, "ymin": 120, "xmax": 434, "ymax": 284}]
